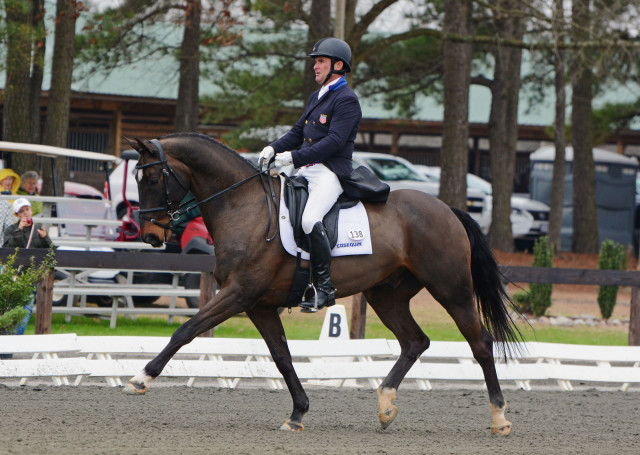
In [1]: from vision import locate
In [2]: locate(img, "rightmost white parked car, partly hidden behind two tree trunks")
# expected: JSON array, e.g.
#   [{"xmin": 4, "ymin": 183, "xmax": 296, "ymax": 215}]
[{"xmin": 416, "ymin": 165, "xmax": 550, "ymax": 248}]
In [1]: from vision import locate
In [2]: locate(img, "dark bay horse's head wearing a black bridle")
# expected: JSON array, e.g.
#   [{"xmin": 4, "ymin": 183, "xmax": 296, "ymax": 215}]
[{"xmin": 130, "ymin": 139, "xmax": 190, "ymax": 247}]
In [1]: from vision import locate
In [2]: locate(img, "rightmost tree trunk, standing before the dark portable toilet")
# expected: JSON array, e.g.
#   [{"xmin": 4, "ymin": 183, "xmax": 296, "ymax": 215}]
[{"xmin": 571, "ymin": 0, "xmax": 599, "ymax": 254}]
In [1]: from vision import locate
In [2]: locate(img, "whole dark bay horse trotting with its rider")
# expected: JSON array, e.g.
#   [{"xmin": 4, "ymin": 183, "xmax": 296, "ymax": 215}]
[{"xmin": 125, "ymin": 134, "xmax": 521, "ymax": 435}]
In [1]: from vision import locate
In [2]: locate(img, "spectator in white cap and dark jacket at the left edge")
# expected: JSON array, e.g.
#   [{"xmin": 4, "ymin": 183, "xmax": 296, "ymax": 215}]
[{"xmin": 2, "ymin": 197, "xmax": 53, "ymax": 248}]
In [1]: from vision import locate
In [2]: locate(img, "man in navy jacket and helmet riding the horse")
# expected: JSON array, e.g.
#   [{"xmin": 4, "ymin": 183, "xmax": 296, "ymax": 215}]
[{"xmin": 260, "ymin": 38, "xmax": 362, "ymax": 311}]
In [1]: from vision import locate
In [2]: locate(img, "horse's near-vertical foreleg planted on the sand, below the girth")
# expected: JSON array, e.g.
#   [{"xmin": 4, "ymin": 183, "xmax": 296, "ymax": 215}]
[{"xmin": 247, "ymin": 307, "xmax": 309, "ymax": 431}]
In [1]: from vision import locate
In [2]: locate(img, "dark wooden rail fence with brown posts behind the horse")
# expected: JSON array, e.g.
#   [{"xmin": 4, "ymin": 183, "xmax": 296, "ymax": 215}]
[{"xmin": 0, "ymin": 248, "xmax": 640, "ymax": 346}]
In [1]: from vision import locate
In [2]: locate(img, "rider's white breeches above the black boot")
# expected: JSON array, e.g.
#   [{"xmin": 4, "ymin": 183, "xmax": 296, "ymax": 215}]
[{"xmin": 298, "ymin": 164, "xmax": 342, "ymax": 234}]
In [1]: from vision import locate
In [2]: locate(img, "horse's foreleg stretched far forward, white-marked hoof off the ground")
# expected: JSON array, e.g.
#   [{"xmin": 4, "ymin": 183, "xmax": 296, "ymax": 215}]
[{"xmin": 124, "ymin": 288, "xmax": 244, "ymax": 394}]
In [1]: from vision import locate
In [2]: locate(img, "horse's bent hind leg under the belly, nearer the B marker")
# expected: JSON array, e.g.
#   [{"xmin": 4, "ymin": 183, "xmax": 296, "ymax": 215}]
[{"xmin": 365, "ymin": 277, "xmax": 430, "ymax": 428}]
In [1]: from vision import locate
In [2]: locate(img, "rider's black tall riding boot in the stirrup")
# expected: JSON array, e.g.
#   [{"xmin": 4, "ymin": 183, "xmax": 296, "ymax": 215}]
[{"xmin": 300, "ymin": 221, "xmax": 336, "ymax": 313}]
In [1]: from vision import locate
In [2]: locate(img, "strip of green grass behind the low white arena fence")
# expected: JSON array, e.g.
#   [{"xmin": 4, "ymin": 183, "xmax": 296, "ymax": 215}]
[{"xmin": 26, "ymin": 309, "xmax": 628, "ymax": 346}]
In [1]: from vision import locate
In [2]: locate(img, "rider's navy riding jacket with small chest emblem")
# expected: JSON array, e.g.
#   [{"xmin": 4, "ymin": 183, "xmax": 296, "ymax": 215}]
[{"xmin": 271, "ymin": 76, "xmax": 362, "ymax": 177}]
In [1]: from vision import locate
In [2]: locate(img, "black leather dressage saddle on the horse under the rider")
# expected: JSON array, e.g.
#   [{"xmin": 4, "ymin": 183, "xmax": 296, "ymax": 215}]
[{"xmin": 281, "ymin": 166, "xmax": 390, "ymax": 308}]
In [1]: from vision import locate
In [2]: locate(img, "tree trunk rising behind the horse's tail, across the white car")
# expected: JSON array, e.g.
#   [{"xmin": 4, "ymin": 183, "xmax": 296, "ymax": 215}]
[{"xmin": 489, "ymin": 1, "xmax": 522, "ymax": 251}]
